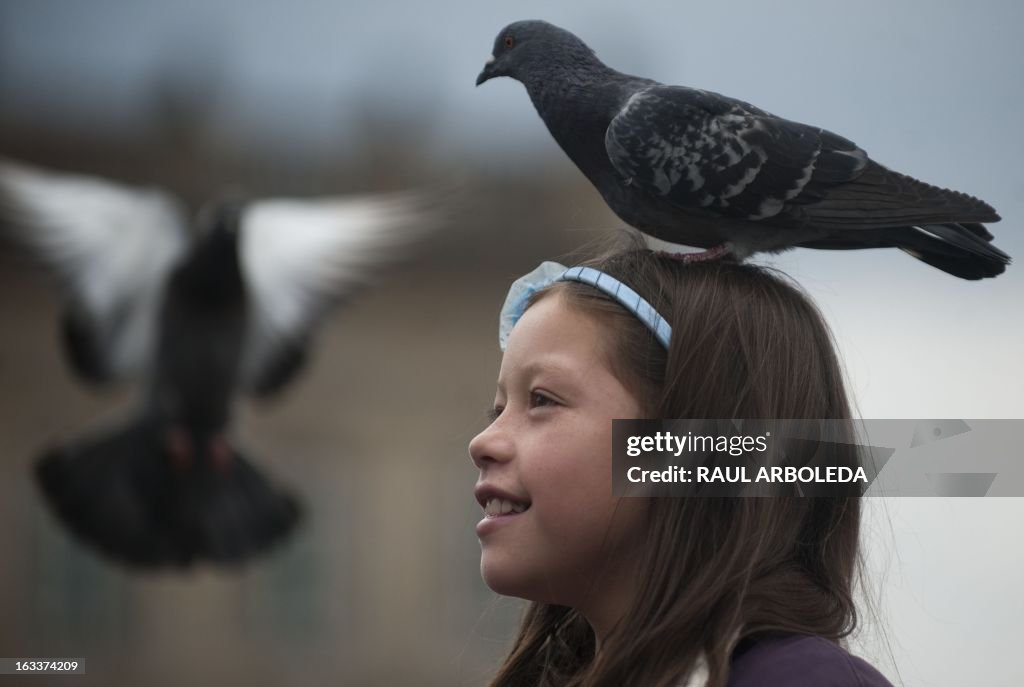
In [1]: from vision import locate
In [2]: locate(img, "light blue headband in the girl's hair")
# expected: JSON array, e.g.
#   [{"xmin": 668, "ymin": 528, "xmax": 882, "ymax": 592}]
[{"xmin": 498, "ymin": 261, "xmax": 672, "ymax": 350}]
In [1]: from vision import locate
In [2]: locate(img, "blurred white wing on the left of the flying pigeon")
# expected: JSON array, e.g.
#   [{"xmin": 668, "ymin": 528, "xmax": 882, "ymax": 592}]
[{"xmin": 0, "ymin": 159, "xmax": 188, "ymax": 381}]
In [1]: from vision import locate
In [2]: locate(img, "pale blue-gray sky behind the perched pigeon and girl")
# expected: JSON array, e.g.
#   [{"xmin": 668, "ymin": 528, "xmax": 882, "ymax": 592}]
[{"xmin": 0, "ymin": 0, "xmax": 1024, "ymax": 686}]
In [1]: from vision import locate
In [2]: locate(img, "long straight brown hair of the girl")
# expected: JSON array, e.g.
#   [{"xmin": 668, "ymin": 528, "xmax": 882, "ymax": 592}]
[{"xmin": 492, "ymin": 247, "xmax": 861, "ymax": 687}]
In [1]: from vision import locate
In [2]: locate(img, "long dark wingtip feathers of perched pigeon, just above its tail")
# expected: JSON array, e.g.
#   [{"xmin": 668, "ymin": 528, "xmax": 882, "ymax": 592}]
[{"xmin": 795, "ymin": 162, "xmax": 999, "ymax": 228}]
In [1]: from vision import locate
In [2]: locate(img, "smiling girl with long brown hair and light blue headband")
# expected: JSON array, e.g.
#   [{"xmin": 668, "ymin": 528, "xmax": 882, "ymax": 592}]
[{"xmin": 469, "ymin": 249, "xmax": 890, "ymax": 687}]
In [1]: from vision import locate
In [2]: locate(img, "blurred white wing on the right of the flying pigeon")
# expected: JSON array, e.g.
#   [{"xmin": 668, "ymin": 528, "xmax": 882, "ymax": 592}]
[{"xmin": 241, "ymin": 191, "xmax": 439, "ymax": 395}]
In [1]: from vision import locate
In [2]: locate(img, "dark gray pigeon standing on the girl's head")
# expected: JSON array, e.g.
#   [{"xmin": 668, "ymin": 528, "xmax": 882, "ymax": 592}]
[{"xmin": 476, "ymin": 20, "xmax": 1010, "ymax": 280}]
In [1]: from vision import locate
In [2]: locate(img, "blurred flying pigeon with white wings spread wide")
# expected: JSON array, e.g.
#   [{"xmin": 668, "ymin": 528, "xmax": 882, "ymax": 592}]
[{"xmin": 0, "ymin": 160, "xmax": 438, "ymax": 568}]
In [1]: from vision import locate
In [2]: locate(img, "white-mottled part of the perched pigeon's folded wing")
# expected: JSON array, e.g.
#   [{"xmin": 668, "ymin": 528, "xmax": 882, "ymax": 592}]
[{"xmin": 604, "ymin": 85, "xmax": 867, "ymax": 220}]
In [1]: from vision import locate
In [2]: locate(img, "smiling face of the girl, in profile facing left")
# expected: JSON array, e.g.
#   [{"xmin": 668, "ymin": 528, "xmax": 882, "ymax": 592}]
[{"xmin": 469, "ymin": 293, "xmax": 645, "ymax": 608}]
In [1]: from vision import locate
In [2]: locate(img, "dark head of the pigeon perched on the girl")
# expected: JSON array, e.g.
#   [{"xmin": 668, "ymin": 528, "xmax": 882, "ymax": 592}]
[{"xmin": 476, "ymin": 19, "xmax": 597, "ymax": 86}]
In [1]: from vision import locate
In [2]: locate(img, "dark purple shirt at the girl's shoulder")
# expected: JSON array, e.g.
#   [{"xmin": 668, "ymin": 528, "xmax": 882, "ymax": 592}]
[{"xmin": 728, "ymin": 634, "xmax": 893, "ymax": 687}]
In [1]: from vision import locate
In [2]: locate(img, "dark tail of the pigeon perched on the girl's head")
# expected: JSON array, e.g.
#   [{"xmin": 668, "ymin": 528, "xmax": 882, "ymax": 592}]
[{"xmin": 894, "ymin": 223, "xmax": 1011, "ymax": 280}]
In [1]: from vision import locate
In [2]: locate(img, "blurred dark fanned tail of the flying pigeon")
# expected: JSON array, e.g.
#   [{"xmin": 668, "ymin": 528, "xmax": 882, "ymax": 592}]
[{"xmin": 36, "ymin": 420, "xmax": 300, "ymax": 568}]
